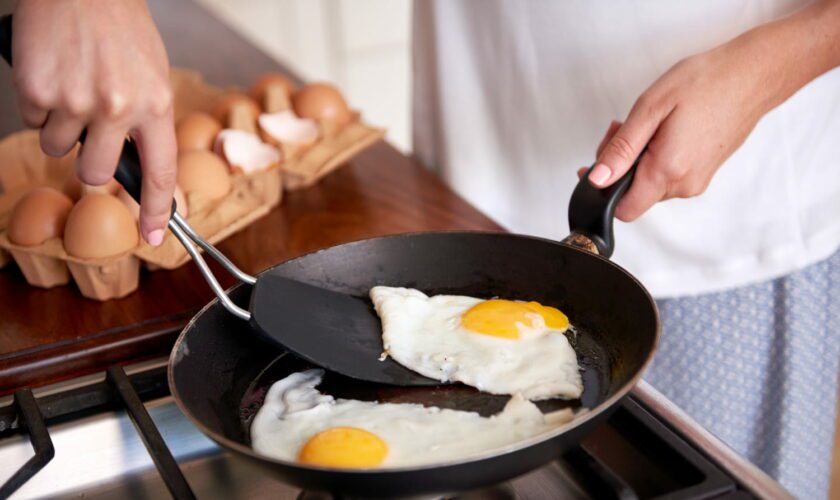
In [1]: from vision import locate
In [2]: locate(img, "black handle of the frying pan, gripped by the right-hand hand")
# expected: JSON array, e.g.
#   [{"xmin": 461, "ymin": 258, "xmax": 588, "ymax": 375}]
[{"xmin": 563, "ymin": 153, "xmax": 647, "ymax": 258}]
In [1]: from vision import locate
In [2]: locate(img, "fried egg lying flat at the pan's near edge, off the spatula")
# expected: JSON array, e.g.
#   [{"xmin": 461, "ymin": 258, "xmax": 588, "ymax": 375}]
[{"xmin": 251, "ymin": 369, "xmax": 573, "ymax": 468}]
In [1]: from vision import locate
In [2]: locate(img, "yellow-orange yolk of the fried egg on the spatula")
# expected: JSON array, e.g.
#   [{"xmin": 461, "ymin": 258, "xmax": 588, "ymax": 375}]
[{"xmin": 461, "ymin": 299, "xmax": 569, "ymax": 340}]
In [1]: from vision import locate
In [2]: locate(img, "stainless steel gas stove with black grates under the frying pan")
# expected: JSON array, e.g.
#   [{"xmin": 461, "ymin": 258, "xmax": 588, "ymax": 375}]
[{"xmin": 0, "ymin": 359, "xmax": 792, "ymax": 500}]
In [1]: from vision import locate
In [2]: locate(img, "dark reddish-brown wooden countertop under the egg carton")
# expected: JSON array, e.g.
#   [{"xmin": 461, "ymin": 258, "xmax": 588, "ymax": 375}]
[{"xmin": 0, "ymin": 0, "xmax": 500, "ymax": 395}]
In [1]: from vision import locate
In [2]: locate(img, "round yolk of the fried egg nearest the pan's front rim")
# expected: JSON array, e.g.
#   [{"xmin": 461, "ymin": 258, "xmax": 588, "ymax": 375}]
[{"xmin": 298, "ymin": 427, "xmax": 388, "ymax": 468}]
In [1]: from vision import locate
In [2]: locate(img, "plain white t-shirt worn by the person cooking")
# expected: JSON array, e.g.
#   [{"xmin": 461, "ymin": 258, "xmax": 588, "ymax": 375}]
[{"xmin": 414, "ymin": 0, "xmax": 840, "ymax": 297}]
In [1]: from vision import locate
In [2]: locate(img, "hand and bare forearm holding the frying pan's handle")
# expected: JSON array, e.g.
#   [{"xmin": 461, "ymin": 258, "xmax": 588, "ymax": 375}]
[{"xmin": 589, "ymin": 1, "xmax": 840, "ymax": 222}]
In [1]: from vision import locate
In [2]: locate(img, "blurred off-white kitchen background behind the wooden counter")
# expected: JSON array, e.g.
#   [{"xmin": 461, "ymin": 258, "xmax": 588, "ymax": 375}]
[{"xmin": 191, "ymin": 0, "xmax": 411, "ymax": 151}]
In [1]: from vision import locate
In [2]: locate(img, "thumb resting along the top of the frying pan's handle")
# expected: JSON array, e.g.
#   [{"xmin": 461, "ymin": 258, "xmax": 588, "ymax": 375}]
[{"xmin": 589, "ymin": 97, "xmax": 668, "ymax": 188}]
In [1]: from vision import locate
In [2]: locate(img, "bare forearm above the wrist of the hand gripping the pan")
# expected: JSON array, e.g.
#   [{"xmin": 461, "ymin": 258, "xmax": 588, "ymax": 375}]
[{"xmin": 732, "ymin": 0, "xmax": 840, "ymax": 112}]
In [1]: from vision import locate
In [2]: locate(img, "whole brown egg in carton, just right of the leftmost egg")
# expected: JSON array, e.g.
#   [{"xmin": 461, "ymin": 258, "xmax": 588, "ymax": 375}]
[{"xmin": 64, "ymin": 193, "xmax": 140, "ymax": 259}]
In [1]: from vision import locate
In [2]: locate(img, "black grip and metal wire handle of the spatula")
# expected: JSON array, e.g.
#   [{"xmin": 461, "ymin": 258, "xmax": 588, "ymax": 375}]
[{"xmin": 0, "ymin": 14, "xmax": 257, "ymax": 320}]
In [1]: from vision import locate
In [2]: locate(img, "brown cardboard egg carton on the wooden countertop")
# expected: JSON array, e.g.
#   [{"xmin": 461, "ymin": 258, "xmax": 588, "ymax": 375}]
[{"xmin": 0, "ymin": 70, "xmax": 384, "ymax": 300}]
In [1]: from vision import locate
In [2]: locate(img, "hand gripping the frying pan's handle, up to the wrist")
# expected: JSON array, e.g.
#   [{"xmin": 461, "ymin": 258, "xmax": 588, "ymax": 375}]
[{"xmin": 589, "ymin": 49, "xmax": 765, "ymax": 222}]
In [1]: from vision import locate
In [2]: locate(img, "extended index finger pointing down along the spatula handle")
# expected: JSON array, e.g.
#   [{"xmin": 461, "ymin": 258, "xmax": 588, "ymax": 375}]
[{"xmin": 133, "ymin": 112, "xmax": 176, "ymax": 246}]
